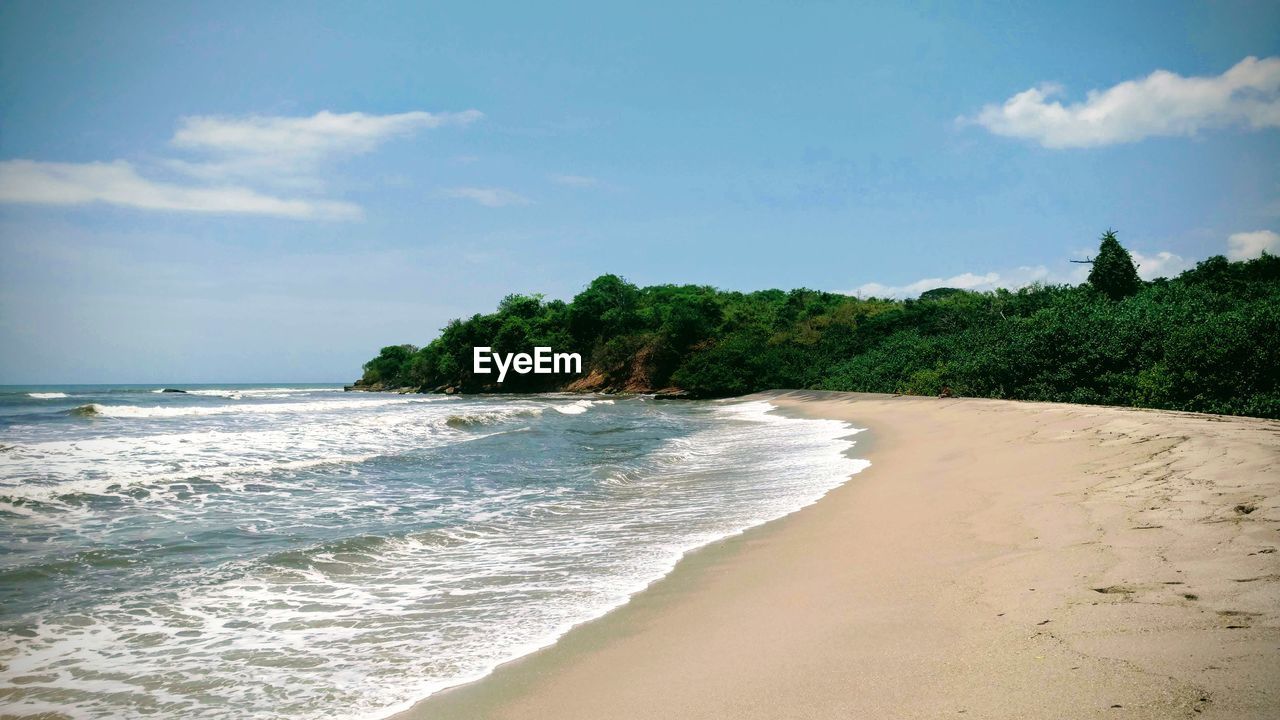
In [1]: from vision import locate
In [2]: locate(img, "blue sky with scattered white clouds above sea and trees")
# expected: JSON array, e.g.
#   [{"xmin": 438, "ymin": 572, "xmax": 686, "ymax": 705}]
[{"xmin": 0, "ymin": 1, "xmax": 1280, "ymax": 384}]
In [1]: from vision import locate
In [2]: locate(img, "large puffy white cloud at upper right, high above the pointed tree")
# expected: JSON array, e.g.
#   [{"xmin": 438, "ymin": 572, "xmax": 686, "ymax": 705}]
[{"xmin": 961, "ymin": 56, "xmax": 1280, "ymax": 147}]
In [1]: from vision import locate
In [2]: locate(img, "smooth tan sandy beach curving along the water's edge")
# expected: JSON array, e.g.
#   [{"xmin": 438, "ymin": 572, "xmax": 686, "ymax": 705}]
[{"xmin": 406, "ymin": 392, "xmax": 1280, "ymax": 720}]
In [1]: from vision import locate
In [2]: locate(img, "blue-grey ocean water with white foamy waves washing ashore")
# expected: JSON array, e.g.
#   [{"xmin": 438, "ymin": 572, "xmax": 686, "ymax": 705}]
[{"xmin": 0, "ymin": 386, "xmax": 867, "ymax": 719}]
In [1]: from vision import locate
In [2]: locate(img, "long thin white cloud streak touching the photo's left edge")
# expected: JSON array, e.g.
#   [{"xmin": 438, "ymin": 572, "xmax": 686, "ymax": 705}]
[{"xmin": 0, "ymin": 160, "xmax": 361, "ymax": 220}]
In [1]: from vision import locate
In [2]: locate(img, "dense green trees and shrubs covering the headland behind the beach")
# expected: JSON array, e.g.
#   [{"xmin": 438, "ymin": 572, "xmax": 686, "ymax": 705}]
[{"xmin": 361, "ymin": 233, "xmax": 1280, "ymax": 418}]
